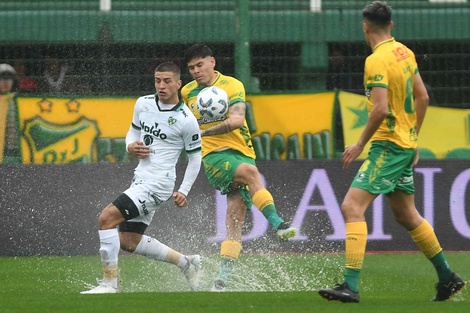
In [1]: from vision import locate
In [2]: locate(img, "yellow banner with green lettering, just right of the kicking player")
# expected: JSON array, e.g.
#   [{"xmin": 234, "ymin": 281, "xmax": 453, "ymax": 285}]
[{"xmin": 247, "ymin": 92, "xmax": 335, "ymax": 160}]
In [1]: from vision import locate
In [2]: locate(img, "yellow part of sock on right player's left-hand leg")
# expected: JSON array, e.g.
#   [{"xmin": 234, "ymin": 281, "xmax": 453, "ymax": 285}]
[{"xmin": 346, "ymin": 222, "xmax": 367, "ymax": 270}]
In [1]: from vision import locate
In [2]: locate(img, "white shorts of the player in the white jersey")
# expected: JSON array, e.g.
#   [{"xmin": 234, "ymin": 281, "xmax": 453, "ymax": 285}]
[{"xmin": 124, "ymin": 180, "xmax": 175, "ymax": 225}]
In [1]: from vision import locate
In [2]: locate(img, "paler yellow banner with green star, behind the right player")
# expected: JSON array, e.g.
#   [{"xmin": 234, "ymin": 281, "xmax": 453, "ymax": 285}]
[{"xmin": 339, "ymin": 92, "xmax": 470, "ymax": 159}]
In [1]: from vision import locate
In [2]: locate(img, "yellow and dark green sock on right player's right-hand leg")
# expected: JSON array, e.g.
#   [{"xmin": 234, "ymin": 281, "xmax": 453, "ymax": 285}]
[{"xmin": 409, "ymin": 220, "xmax": 452, "ymax": 283}]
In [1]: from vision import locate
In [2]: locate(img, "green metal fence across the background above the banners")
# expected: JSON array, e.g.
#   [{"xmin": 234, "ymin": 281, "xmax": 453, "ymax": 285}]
[{"xmin": 0, "ymin": 0, "xmax": 470, "ymax": 108}]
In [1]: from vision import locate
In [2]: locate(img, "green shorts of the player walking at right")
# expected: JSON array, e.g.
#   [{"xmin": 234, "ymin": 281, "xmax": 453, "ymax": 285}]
[{"xmin": 351, "ymin": 141, "xmax": 416, "ymax": 194}]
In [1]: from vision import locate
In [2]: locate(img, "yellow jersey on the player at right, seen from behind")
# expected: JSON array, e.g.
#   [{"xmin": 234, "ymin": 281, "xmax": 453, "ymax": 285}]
[{"xmin": 364, "ymin": 38, "xmax": 418, "ymax": 148}]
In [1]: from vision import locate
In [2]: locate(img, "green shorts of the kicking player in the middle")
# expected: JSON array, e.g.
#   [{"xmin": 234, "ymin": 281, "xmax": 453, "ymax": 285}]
[{"xmin": 202, "ymin": 149, "xmax": 256, "ymax": 209}]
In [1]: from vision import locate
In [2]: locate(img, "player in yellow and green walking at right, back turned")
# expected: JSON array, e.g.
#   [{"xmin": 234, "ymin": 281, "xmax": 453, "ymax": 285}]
[{"xmin": 318, "ymin": 1, "xmax": 465, "ymax": 302}]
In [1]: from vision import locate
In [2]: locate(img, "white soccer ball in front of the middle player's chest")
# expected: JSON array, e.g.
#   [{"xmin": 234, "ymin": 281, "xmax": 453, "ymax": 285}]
[{"xmin": 196, "ymin": 86, "xmax": 229, "ymax": 121}]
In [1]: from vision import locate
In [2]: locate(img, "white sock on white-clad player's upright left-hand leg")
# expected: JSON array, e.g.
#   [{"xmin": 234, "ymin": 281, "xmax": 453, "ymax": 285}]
[{"xmin": 98, "ymin": 228, "xmax": 120, "ymax": 288}]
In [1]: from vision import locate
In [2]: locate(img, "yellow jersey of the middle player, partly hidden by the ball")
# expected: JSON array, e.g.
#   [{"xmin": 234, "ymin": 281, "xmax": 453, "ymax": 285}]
[{"xmin": 181, "ymin": 72, "xmax": 256, "ymax": 159}]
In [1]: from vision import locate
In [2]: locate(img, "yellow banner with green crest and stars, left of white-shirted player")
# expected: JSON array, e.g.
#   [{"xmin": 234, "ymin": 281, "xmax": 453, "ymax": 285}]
[{"xmin": 18, "ymin": 98, "xmax": 135, "ymax": 164}]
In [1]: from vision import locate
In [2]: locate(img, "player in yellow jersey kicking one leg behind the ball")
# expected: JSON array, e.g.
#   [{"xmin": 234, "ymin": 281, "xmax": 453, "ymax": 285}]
[{"xmin": 181, "ymin": 44, "xmax": 297, "ymax": 291}]
